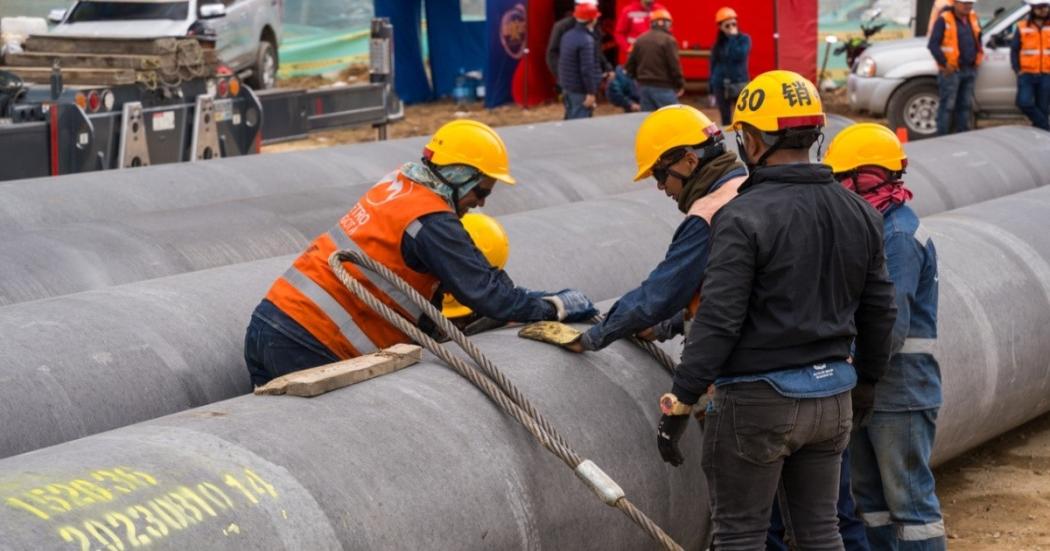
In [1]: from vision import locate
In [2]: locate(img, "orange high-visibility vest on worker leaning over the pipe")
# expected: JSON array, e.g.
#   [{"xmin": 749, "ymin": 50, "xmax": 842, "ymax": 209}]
[{"xmin": 266, "ymin": 172, "xmax": 454, "ymax": 359}]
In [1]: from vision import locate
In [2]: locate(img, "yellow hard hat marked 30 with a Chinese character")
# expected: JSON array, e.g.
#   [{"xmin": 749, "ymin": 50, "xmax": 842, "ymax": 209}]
[{"xmin": 733, "ymin": 70, "xmax": 827, "ymax": 132}]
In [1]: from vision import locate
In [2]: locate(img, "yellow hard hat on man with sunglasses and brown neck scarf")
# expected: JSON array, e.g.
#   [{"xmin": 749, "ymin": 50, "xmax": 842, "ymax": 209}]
[{"xmin": 634, "ymin": 105, "xmax": 721, "ymax": 182}]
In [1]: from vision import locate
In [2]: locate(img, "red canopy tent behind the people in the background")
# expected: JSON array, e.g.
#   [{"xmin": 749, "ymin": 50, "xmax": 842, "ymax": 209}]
[{"xmin": 513, "ymin": 0, "xmax": 817, "ymax": 105}]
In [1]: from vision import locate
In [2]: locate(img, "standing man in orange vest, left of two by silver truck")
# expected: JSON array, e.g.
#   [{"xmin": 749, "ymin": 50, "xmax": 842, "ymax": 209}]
[{"xmin": 926, "ymin": 0, "xmax": 984, "ymax": 135}]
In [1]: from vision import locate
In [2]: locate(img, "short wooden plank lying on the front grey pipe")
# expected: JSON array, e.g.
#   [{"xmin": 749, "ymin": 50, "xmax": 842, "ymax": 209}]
[{"xmin": 255, "ymin": 344, "xmax": 423, "ymax": 398}]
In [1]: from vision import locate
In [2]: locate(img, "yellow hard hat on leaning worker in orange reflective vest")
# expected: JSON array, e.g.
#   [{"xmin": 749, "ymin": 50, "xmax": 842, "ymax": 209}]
[{"xmin": 423, "ymin": 119, "xmax": 516, "ymax": 186}]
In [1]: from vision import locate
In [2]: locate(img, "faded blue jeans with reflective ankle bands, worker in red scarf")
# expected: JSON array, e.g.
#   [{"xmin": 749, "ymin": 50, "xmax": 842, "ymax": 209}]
[{"xmin": 849, "ymin": 408, "xmax": 947, "ymax": 551}]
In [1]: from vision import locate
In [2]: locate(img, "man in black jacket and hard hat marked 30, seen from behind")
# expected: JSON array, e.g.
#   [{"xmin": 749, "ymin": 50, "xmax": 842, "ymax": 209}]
[{"xmin": 657, "ymin": 70, "xmax": 895, "ymax": 550}]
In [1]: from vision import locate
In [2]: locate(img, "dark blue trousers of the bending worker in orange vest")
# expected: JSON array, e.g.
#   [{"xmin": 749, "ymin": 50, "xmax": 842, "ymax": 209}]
[{"xmin": 245, "ymin": 306, "xmax": 339, "ymax": 386}]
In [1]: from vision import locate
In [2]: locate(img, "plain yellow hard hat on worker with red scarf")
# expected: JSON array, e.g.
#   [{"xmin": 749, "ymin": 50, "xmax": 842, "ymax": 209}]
[{"xmin": 824, "ymin": 123, "xmax": 908, "ymax": 174}]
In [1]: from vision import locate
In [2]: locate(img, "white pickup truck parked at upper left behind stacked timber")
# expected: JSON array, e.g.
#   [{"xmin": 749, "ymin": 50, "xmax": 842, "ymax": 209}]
[{"xmin": 48, "ymin": 0, "xmax": 282, "ymax": 90}]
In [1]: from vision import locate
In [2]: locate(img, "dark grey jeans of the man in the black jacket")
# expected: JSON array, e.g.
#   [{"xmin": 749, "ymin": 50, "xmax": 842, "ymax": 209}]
[{"xmin": 702, "ymin": 382, "xmax": 853, "ymax": 551}]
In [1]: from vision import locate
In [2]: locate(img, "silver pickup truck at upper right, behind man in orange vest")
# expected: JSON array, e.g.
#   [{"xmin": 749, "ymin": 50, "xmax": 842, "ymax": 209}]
[{"xmin": 846, "ymin": 2, "xmax": 1029, "ymax": 139}]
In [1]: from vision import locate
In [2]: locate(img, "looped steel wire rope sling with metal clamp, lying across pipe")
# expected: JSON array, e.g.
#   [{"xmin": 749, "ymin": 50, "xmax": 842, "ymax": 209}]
[{"xmin": 329, "ymin": 251, "xmax": 681, "ymax": 550}]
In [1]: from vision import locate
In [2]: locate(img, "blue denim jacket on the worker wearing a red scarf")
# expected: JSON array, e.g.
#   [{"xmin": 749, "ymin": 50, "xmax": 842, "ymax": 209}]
[{"xmin": 875, "ymin": 205, "xmax": 941, "ymax": 411}]
